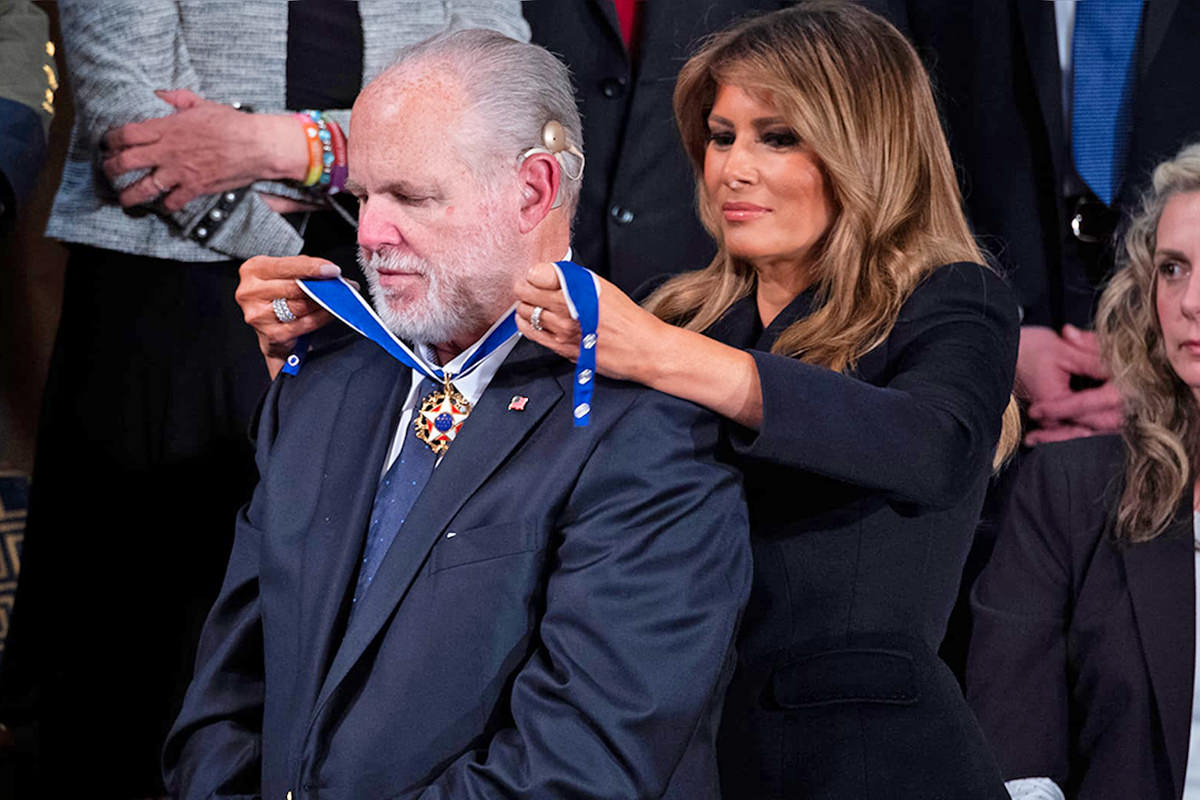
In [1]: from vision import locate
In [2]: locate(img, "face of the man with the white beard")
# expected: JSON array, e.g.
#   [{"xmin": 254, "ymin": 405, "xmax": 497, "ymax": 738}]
[{"xmin": 349, "ymin": 77, "xmax": 523, "ymax": 344}]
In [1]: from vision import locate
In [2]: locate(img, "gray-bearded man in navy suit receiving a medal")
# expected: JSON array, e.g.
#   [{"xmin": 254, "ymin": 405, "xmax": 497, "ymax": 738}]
[{"xmin": 164, "ymin": 31, "xmax": 750, "ymax": 800}]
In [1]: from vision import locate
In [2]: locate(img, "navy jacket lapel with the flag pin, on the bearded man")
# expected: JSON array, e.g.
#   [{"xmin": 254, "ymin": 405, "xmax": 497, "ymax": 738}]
[{"xmin": 314, "ymin": 341, "xmax": 565, "ymax": 714}]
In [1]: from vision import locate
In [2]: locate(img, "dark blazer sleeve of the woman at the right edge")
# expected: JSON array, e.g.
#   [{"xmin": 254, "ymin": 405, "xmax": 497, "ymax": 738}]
[{"xmin": 966, "ymin": 450, "xmax": 1080, "ymax": 786}]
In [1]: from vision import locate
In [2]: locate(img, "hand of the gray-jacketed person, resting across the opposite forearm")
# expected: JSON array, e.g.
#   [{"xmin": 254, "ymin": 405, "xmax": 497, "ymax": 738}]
[{"xmin": 103, "ymin": 89, "xmax": 308, "ymax": 212}]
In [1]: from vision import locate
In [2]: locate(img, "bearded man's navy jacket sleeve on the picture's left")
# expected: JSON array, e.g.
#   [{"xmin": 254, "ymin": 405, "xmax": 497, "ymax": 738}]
[{"xmin": 163, "ymin": 380, "xmax": 287, "ymax": 800}]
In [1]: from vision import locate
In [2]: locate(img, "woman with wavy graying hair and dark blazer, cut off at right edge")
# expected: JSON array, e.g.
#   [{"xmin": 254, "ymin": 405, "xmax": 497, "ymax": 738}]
[{"xmin": 967, "ymin": 145, "xmax": 1200, "ymax": 800}]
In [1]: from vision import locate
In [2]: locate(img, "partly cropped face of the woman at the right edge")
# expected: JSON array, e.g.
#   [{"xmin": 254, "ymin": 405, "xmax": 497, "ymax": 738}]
[{"xmin": 1154, "ymin": 192, "xmax": 1200, "ymax": 399}]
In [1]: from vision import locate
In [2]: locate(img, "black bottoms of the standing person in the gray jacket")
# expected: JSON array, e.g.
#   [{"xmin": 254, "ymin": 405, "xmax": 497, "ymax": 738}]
[{"xmin": 0, "ymin": 215, "xmax": 353, "ymax": 798}]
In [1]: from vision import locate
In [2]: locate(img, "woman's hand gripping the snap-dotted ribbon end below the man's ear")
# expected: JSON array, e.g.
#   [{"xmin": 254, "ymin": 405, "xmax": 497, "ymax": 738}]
[{"xmin": 515, "ymin": 263, "xmax": 674, "ymax": 385}]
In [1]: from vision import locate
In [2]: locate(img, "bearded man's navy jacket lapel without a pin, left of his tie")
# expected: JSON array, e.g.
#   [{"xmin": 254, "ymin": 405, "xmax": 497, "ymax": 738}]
[{"xmin": 299, "ymin": 350, "xmax": 412, "ymax": 692}]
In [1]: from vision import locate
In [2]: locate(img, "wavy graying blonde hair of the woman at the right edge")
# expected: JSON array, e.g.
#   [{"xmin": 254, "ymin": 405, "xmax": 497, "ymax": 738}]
[{"xmin": 1096, "ymin": 144, "xmax": 1200, "ymax": 542}]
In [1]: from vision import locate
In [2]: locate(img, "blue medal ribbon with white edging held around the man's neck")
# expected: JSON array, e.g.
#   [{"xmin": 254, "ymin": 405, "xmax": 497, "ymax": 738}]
[{"xmin": 283, "ymin": 261, "xmax": 600, "ymax": 427}]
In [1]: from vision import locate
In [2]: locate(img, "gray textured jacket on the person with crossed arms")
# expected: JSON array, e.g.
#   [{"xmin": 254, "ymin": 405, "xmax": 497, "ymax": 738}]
[{"xmin": 46, "ymin": 0, "xmax": 529, "ymax": 261}]
